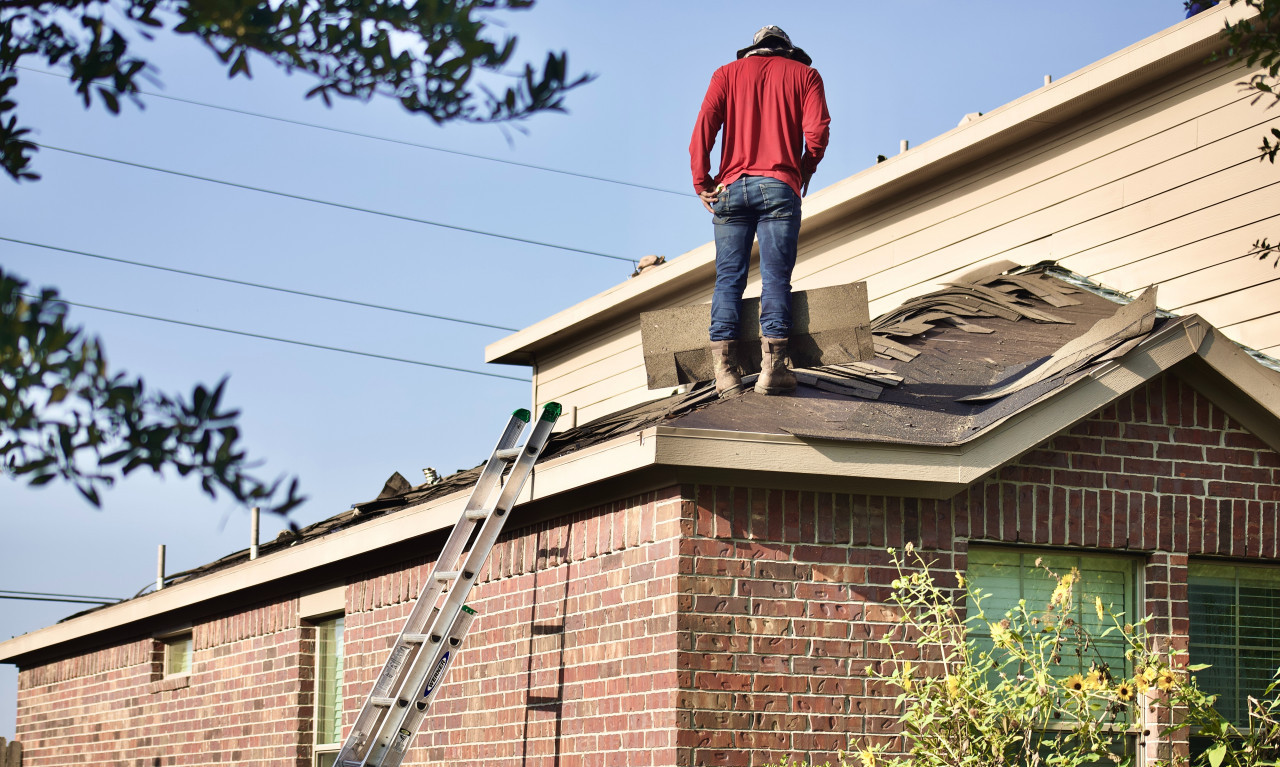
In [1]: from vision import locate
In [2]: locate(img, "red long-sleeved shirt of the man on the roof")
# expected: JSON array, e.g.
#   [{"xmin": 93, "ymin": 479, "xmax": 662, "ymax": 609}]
[{"xmin": 689, "ymin": 55, "xmax": 831, "ymax": 195}]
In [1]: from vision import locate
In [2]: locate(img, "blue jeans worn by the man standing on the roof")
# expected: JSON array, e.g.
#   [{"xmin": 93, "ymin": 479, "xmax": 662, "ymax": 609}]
[{"xmin": 710, "ymin": 175, "xmax": 800, "ymax": 341}]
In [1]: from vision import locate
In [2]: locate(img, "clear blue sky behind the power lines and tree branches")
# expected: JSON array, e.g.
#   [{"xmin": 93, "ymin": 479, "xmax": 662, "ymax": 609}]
[{"xmin": 0, "ymin": 0, "xmax": 1198, "ymax": 738}]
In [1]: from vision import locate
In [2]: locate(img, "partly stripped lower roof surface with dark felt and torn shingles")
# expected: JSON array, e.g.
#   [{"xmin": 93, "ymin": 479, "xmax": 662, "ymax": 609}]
[{"xmin": 74, "ymin": 262, "xmax": 1184, "ymax": 606}]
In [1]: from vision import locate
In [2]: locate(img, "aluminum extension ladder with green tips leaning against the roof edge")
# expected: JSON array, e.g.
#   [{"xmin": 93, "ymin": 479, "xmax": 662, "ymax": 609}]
[{"xmin": 334, "ymin": 402, "xmax": 561, "ymax": 767}]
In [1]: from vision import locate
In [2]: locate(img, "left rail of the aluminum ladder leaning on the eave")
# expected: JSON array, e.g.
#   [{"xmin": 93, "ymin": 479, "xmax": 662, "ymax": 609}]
[{"xmin": 342, "ymin": 408, "xmax": 531, "ymax": 764}]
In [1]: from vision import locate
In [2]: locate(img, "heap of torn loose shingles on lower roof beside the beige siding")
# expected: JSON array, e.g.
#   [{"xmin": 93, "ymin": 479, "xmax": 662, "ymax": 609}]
[{"xmin": 872, "ymin": 273, "xmax": 1080, "ymax": 362}]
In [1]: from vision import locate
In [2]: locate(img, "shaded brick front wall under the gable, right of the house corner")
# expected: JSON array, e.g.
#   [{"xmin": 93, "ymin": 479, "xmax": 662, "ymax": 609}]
[{"xmin": 677, "ymin": 375, "xmax": 1280, "ymax": 766}]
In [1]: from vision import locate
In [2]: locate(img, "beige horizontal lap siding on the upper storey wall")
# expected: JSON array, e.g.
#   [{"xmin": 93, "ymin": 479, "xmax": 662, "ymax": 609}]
[{"xmin": 536, "ymin": 56, "xmax": 1280, "ymax": 423}]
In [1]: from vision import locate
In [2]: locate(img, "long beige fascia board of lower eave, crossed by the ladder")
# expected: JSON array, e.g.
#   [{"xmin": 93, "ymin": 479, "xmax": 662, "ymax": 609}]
[{"xmin": 0, "ymin": 429, "xmax": 655, "ymax": 663}]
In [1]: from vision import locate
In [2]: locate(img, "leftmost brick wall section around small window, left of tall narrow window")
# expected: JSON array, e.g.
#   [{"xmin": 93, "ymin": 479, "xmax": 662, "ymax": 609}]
[{"xmin": 18, "ymin": 601, "xmax": 314, "ymax": 767}]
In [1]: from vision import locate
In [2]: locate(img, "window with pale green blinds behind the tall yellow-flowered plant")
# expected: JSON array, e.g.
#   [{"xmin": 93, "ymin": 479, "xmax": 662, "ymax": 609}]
[{"xmin": 966, "ymin": 548, "xmax": 1138, "ymax": 679}]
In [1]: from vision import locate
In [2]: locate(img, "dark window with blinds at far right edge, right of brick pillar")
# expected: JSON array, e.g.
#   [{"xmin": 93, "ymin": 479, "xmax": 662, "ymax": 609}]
[{"xmin": 1187, "ymin": 562, "xmax": 1280, "ymax": 725}]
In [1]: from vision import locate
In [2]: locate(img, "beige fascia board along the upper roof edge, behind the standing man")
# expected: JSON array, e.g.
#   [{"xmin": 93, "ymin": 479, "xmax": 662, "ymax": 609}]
[{"xmin": 485, "ymin": 3, "xmax": 1256, "ymax": 365}]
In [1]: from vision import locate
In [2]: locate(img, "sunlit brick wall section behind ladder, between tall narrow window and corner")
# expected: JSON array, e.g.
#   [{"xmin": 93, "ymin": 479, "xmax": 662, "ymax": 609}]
[{"xmin": 346, "ymin": 488, "xmax": 681, "ymax": 767}]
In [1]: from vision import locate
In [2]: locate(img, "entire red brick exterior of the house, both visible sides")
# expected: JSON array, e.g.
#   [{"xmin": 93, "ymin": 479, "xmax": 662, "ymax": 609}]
[{"xmin": 18, "ymin": 376, "xmax": 1280, "ymax": 767}]
